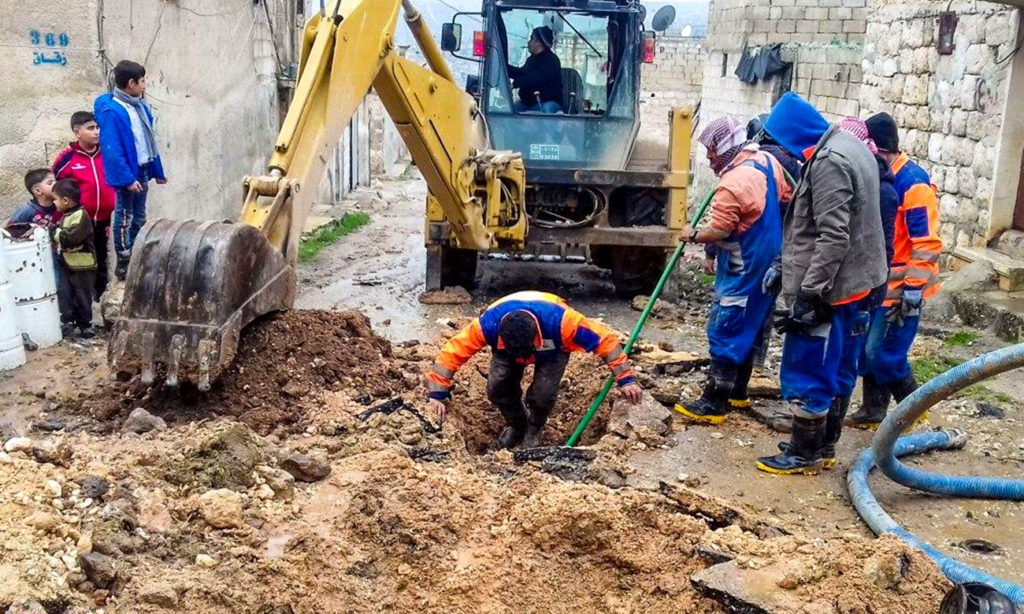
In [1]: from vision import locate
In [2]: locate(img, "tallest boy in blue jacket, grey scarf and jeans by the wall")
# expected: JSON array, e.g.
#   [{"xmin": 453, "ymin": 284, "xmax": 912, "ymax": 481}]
[{"xmin": 93, "ymin": 59, "xmax": 167, "ymax": 280}]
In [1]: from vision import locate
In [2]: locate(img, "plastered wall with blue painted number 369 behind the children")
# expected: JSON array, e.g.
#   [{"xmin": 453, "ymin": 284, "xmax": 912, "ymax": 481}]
[{"xmin": 0, "ymin": 0, "xmax": 291, "ymax": 224}]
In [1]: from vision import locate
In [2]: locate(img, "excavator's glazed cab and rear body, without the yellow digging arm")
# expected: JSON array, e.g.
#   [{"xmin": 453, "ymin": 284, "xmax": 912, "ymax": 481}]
[{"xmin": 428, "ymin": 0, "xmax": 689, "ymax": 296}]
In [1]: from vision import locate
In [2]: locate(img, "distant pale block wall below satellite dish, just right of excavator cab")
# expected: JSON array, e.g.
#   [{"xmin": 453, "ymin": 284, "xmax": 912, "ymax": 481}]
[{"xmin": 640, "ymin": 36, "xmax": 708, "ymax": 143}]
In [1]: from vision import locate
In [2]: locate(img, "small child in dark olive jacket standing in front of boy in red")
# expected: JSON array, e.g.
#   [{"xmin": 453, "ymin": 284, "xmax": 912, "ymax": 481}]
[{"xmin": 53, "ymin": 179, "xmax": 96, "ymax": 339}]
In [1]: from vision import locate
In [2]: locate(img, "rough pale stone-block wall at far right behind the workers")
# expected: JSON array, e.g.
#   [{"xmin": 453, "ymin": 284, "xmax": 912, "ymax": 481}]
[{"xmin": 860, "ymin": 0, "xmax": 1022, "ymax": 248}]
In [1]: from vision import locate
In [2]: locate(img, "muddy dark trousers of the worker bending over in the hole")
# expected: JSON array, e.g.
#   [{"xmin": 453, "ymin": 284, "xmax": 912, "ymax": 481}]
[{"xmin": 487, "ymin": 352, "xmax": 569, "ymax": 429}]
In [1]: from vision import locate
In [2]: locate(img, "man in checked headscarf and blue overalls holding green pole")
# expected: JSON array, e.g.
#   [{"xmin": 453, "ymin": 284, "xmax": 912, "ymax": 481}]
[{"xmin": 676, "ymin": 117, "xmax": 793, "ymax": 424}]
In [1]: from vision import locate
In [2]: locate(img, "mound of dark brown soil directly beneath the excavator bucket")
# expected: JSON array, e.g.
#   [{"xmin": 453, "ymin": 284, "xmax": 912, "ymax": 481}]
[{"xmin": 82, "ymin": 310, "xmax": 403, "ymax": 435}]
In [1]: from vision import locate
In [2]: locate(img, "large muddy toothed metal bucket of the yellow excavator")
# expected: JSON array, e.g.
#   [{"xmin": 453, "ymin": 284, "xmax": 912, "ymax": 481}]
[{"xmin": 108, "ymin": 219, "xmax": 295, "ymax": 390}]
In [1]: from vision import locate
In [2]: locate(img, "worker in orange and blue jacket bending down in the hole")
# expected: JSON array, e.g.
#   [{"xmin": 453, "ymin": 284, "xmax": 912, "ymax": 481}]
[{"xmin": 427, "ymin": 292, "xmax": 641, "ymax": 448}]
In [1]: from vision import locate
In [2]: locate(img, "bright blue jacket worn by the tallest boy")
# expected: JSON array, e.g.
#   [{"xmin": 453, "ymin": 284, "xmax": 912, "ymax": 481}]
[{"xmin": 93, "ymin": 93, "xmax": 166, "ymax": 187}]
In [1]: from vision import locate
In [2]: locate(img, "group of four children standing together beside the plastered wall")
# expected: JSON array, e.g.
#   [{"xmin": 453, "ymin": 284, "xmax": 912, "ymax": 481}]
[{"xmin": 7, "ymin": 60, "xmax": 167, "ymax": 339}]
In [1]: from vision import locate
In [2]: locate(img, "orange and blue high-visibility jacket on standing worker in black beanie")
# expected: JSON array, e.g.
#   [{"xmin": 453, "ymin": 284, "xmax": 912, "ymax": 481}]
[{"xmin": 884, "ymin": 154, "xmax": 942, "ymax": 307}]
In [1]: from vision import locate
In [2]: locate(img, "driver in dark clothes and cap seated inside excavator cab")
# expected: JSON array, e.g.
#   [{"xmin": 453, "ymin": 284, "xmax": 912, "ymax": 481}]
[{"xmin": 508, "ymin": 26, "xmax": 563, "ymax": 113}]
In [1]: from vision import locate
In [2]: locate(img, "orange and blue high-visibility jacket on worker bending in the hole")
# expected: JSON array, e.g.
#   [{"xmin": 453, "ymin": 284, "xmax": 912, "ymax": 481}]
[{"xmin": 427, "ymin": 292, "xmax": 635, "ymax": 400}]
